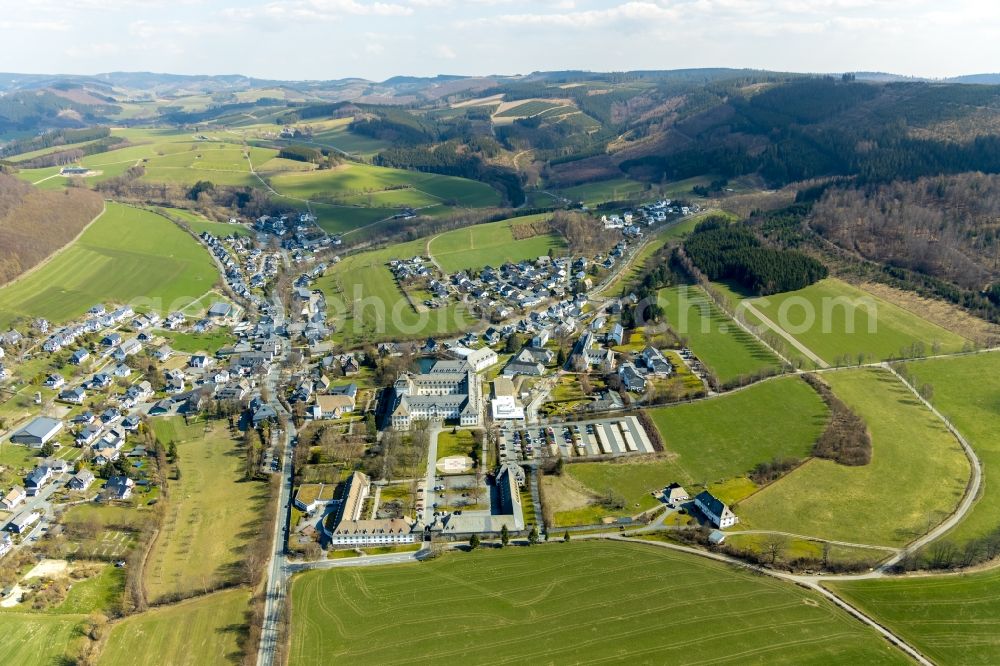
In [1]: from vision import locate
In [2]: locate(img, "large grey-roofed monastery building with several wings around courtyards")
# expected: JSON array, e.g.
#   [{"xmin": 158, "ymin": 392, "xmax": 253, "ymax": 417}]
[{"xmin": 390, "ymin": 361, "xmax": 482, "ymax": 430}]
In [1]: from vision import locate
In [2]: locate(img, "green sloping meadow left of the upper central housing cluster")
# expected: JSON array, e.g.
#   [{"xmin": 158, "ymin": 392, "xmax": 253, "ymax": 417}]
[{"xmin": 316, "ymin": 241, "xmax": 473, "ymax": 344}]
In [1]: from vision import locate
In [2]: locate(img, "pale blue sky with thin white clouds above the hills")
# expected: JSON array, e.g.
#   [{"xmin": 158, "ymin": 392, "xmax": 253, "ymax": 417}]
[{"xmin": 0, "ymin": 0, "xmax": 1000, "ymax": 80}]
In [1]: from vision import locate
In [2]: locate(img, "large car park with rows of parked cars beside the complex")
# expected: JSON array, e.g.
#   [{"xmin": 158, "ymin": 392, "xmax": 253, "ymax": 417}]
[{"xmin": 500, "ymin": 416, "xmax": 654, "ymax": 462}]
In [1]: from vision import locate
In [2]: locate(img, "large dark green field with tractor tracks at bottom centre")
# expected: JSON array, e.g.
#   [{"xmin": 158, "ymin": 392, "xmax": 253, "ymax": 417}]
[{"xmin": 289, "ymin": 542, "xmax": 905, "ymax": 666}]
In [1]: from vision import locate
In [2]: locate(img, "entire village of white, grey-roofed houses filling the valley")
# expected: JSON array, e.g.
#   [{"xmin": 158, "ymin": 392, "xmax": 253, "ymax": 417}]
[{"xmin": 0, "ymin": 201, "xmax": 735, "ymax": 600}]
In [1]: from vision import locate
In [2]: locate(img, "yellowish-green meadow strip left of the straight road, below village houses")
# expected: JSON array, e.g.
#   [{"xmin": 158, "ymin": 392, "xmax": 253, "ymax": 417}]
[{"xmin": 145, "ymin": 418, "xmax": 267, "ymax": 602}]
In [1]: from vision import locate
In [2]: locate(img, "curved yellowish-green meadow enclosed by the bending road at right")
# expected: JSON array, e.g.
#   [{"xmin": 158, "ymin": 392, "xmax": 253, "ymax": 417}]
[{"xmin": 737, "ymin": 369, "xmax": 970, "ymax": 546}]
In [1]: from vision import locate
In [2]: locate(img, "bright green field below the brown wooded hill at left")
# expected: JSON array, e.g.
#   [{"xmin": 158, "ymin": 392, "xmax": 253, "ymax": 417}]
[{"xmin": 0, "ymin": 203, "xmax": 218, "ymax": 327}]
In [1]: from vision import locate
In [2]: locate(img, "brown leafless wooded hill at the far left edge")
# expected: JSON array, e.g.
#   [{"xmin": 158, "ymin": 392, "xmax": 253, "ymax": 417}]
[{"xmin": 0, "ymin": 173, "xmax": 103, "ymax": 284}]
